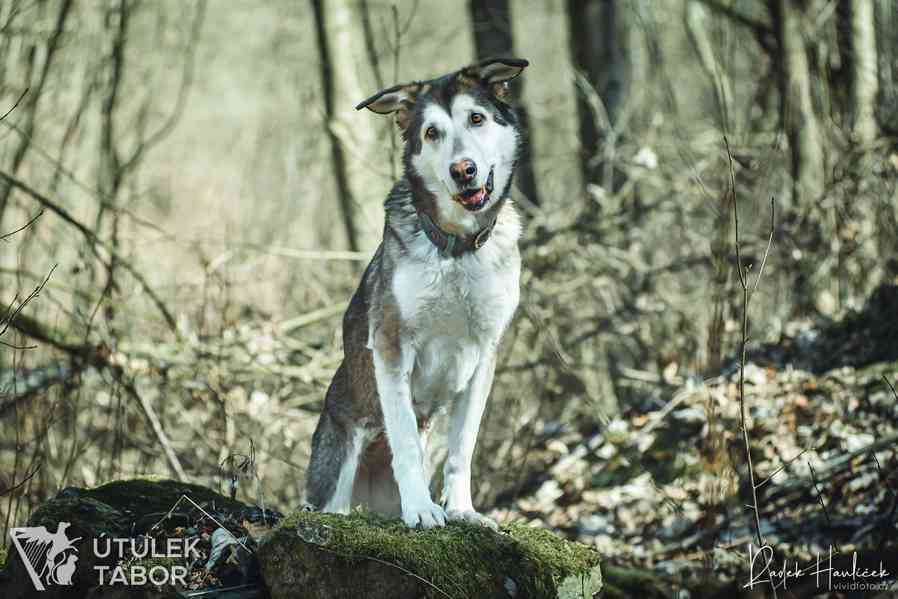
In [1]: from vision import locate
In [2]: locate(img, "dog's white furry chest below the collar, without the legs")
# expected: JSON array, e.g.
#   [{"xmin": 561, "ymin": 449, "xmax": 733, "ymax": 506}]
[{"xmin": 393, "ymin": 248, "xmax": 520, "ymax": 412}]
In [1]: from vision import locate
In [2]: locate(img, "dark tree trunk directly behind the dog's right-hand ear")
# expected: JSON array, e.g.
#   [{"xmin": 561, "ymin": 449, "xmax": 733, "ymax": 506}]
[{"xmin": 468, "ymin": 0, "xmax": 540, "ymax": 206}]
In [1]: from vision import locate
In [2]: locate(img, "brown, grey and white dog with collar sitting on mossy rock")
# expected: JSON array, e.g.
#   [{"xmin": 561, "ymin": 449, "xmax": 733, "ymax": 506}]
[{"xmin": 305, "ymin": 58, "xmax": 529, "ymax": 529}]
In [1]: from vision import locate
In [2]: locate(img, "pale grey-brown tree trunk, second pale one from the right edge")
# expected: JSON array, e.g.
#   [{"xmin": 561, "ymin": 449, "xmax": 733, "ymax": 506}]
[{"xmin": 772, "ymin": 0, "xmax": 824, "ymax": 208}]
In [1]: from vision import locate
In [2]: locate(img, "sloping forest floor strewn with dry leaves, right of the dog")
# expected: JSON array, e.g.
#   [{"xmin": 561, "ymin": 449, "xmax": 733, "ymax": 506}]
[{"xmin": 494, "ymin": 285, "xmax": 898, "ymax": 592}]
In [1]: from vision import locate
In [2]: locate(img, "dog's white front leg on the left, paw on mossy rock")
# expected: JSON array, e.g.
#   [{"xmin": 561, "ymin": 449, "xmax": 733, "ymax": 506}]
[{"xmin": 374, "ymin": 332, "xmax": 446, "ymax": 528}]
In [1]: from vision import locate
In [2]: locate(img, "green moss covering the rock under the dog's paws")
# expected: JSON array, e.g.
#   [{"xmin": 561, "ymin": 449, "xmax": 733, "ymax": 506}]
[{"xmin": 263, "ymin": 512, "xmax": 599, "ymax": 599}]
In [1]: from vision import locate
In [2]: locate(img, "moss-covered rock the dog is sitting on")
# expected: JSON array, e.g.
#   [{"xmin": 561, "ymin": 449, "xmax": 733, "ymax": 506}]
[{"xmin": 259, "ymin": 512, "xmax": 602, "ymax": 599}]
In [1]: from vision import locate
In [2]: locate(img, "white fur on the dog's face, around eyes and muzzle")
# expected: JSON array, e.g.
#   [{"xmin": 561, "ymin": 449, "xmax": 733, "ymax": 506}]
[{"xmin": 412, "ymin": 94, "xmax": 518, "ymax": 233}]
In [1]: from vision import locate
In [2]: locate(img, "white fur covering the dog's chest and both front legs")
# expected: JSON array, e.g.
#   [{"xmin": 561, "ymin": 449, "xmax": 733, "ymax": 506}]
[{"xmin": 374, "ymin": 207, "xmax": 520, "ymax": 526}]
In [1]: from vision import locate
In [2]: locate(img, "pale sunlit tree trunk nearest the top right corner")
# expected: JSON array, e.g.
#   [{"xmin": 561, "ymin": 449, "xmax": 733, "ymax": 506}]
[{"xmin": 840, "ymin": 0, "xmax": 879, "ymax": 145}]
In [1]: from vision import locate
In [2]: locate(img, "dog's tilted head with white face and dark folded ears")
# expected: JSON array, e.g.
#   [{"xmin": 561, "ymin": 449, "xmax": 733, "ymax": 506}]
[{"xmin": 356, "ymin": 58, "xmax": 528, "ymax": 226}]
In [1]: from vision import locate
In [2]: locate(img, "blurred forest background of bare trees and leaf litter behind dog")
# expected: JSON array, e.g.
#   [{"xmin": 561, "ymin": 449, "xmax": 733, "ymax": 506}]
[{"xmin": 0, "ymin": 0, "xmax": 898, "ymax": 592}]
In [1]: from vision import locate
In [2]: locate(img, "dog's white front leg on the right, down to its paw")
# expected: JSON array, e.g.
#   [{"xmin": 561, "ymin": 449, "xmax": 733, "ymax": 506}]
[{"xmin": 440, "ymin": 348, "xmax": 498, "ymax": 529}]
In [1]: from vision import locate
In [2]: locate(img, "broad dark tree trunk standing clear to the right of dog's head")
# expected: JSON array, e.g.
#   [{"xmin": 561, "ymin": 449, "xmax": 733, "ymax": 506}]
[{"xmin": 567, "ymin": 0, "xmax": 630, "ymax": 199}]
